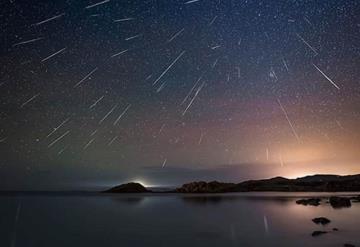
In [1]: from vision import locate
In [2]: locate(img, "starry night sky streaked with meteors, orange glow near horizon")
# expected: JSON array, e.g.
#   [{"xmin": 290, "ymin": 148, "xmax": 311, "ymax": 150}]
[{"xmin": 0, "ymin": 0, "xmax": 360, "ymax": 190}]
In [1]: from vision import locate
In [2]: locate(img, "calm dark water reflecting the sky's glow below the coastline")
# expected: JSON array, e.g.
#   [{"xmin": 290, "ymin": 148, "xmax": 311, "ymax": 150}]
[{"xmin": 0, "ymin": 193, "xmax": 360, "ymax": 247}]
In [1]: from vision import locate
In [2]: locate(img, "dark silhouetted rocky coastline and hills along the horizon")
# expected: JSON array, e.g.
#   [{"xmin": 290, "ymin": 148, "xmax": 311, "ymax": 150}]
[{"xmin": 105, "ymin": 174, "xmax": 360, "ymax": 194}]
